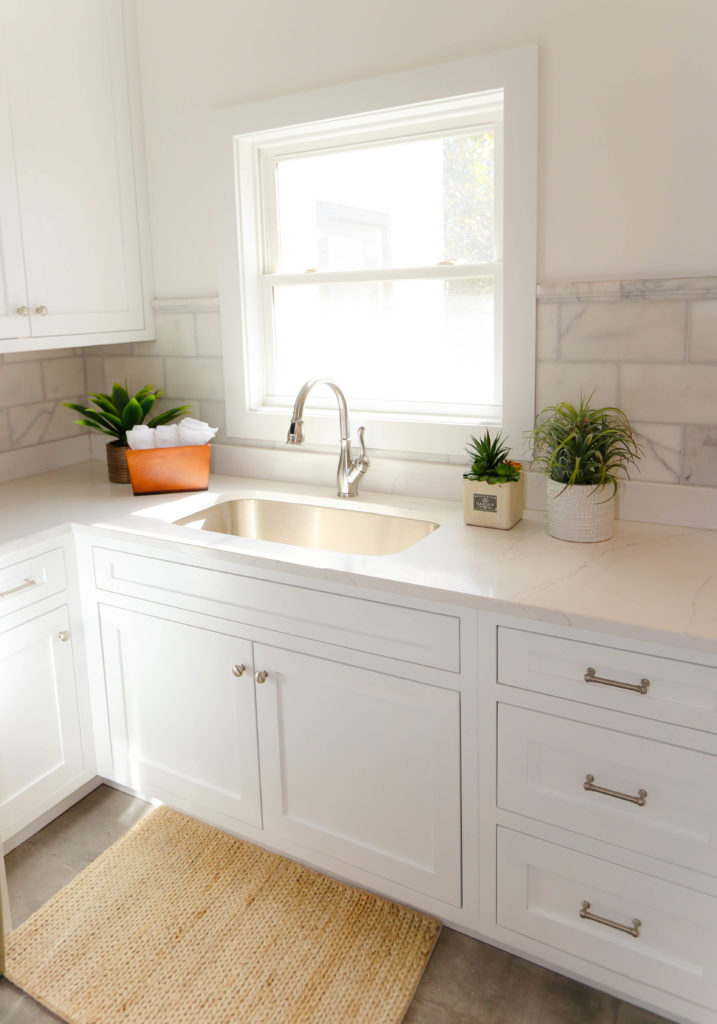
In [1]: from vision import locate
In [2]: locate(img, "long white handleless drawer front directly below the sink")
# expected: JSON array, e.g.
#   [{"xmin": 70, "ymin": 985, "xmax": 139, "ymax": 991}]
[{"xmin": 94, "ymin": 548, "xmax": 460, "ymax": 673}]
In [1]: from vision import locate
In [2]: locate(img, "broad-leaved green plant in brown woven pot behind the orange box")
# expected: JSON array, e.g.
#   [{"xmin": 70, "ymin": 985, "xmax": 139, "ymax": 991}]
[{"xmin": 62, "ymin": 381, "xmax": 189, "ymax": 483}]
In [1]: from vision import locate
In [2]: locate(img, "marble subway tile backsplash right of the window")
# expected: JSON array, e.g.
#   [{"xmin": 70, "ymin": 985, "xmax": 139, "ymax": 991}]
[{"xmin": 536, "ymin": 278, "xmax": 717, "ymax": 487}]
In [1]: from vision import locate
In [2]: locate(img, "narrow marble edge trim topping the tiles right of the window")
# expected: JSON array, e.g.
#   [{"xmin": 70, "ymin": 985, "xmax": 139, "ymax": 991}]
[{"xmin": 538, "ymin": 278, "xmax": 717, "ymax": 302}]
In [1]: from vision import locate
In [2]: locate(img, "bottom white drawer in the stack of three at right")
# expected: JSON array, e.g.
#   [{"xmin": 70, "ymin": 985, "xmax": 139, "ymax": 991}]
[{"xmin": 497, "ymin": 828, "xmax": 717, "ymax": 1007}]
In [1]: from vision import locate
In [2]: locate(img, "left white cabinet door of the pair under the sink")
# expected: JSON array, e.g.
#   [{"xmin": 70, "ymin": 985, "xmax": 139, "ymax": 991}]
[{"xmin": 100, "ymin": 606, "xmax": 261, "ymax": 825}]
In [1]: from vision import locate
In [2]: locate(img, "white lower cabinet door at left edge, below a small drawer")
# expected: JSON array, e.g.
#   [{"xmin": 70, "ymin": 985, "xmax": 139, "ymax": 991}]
[{"xmin": 0, "ymin": 607, "xmax": 84, "ymax": 840}]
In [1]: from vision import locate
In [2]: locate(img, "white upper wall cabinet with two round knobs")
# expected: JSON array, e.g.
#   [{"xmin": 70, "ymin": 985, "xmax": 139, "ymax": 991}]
[{"xmin": 0, "ymin": 0, "xmax": 154, "ymax": 352}]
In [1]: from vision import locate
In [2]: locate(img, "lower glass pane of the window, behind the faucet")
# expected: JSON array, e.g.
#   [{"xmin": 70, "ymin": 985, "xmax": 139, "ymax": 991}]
[{"xmin": 272, "ymin": 278, "xmax": 500, "ymax": 414}]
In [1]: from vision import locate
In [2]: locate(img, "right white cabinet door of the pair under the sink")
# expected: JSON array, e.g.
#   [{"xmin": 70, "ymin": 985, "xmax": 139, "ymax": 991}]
[{"xmin": 254, "ymin": 644, "xmax": 461, "ymax": 905}]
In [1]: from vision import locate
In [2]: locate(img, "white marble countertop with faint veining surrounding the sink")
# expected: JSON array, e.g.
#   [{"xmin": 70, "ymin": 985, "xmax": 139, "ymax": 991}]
[{"xmin": 0, "ymin": 462, "xmax": 717, "ymax": 653}]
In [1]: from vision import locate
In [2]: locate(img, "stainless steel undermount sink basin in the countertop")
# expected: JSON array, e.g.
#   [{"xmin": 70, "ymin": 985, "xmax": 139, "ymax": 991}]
[{"xmin": 176, "ymin": 498, "xmax": 439, "ymax": 555}]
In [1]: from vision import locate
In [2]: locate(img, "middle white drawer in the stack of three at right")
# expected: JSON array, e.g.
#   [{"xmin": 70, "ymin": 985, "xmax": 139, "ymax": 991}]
[{"xmin": 498, "ymin": 705, "xmax": 717, "ymax": 874}]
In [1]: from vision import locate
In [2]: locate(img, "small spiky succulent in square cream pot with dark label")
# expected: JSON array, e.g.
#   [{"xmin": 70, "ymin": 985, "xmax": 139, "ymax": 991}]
[{"xmin": 463, "ymin": 430, "xmax": 522, "ymax": 529}]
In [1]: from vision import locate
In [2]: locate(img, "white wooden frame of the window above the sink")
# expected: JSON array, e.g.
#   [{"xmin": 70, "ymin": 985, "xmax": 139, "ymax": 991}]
[{"xmin": 217, "ymin": 47, "xmax": 538, "ymax": 459}]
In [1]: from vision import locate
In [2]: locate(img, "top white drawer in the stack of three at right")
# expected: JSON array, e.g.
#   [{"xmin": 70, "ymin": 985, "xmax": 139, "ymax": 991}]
[{"xmin": 498, "ymin": 627, "xmax": 717, "ymax": 731}]
